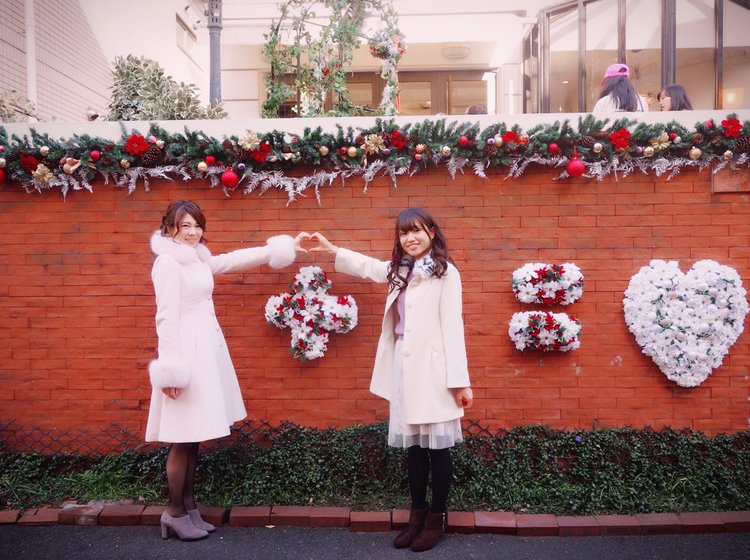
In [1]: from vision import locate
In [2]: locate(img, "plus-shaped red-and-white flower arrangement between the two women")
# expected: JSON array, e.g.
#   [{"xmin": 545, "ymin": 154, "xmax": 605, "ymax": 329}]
[{"xmin": 265, "ymin": 266, "xmax": 357, "ymax": 362}]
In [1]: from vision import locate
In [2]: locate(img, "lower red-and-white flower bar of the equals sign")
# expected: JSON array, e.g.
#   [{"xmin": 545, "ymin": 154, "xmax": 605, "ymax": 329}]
[{"xmin": 508, "ymin": 311, "xmax": 581, "ymax": 352}]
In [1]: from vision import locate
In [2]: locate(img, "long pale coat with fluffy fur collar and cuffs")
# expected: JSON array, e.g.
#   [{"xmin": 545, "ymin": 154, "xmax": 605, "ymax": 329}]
[{"xmin": 146, "ymin": 231, "xmax": 295, "ymax": 443}]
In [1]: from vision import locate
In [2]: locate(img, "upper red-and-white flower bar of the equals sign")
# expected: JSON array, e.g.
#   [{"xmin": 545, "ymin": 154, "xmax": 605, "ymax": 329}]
[{"xmin": 512, "ymin": 263, "xmax": 583, "ymax": 305}]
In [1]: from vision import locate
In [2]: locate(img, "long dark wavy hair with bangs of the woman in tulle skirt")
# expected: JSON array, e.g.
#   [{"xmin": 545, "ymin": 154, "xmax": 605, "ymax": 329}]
[{"xmin": 387, "ymin": 208, "xmax": 453, "ymax": 290}]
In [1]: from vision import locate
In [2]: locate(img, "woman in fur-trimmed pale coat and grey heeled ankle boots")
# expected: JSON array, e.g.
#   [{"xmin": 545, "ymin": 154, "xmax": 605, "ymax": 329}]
[{"xmin": 146, "ymin": 200, "xmax": 310, "ymax": 541}]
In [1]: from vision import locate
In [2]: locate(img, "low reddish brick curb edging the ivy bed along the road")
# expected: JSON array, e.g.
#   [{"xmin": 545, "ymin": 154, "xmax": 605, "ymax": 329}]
[{"xmin": 0, "ymin": 504, "xmax": 750, "ymax": 537}]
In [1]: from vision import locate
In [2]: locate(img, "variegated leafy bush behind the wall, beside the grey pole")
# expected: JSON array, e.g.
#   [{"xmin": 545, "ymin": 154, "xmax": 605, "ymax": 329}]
[{"xmin": 106, "ymin": 55, "xmax": 227, "ymax": 121}]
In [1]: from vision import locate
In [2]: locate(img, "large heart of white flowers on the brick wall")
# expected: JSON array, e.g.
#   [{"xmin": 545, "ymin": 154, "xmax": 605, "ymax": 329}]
[{"xmin": 623, "ymin": 260, "xmax": 748, "ymax": 387}]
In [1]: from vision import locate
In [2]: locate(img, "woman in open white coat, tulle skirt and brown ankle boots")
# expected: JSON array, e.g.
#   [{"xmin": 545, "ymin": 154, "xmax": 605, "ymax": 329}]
[{"xmin": 310, "ymin": 208, "xmax": 474, "ymax": 552}]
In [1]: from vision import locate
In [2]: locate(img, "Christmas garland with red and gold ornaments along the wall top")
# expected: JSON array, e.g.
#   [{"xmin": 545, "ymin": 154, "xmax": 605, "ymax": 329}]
[{"xmin": 0, "ymin": 114, "xmax": 750, "ymax": 202}]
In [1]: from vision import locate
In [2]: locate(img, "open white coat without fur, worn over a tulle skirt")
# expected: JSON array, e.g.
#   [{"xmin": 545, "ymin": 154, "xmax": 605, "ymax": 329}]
[{"xmin": 335, "ymin": 248, "xmax": 471, "ymax": 424}]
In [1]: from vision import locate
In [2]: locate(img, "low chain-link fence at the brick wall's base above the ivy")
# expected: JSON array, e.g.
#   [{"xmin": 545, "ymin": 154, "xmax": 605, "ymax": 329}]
[{"xmin": 0, "ymin": 418, "xmax": 506, "ymax": 455}]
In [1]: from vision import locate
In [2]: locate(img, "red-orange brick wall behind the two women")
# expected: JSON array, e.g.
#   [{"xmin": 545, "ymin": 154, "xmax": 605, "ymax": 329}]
[{"xmin": 0, "ymin": 165, "xmax": 750, "ymax": 442}]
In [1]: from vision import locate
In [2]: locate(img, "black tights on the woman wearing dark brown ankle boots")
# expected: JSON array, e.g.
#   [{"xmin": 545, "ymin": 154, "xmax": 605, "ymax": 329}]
[{"xmin": 406, "ymin": 445, "xmax": 453, "ymax": 513}]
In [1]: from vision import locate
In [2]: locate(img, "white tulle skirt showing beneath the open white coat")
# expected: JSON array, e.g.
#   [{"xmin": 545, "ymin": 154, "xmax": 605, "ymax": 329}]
[{"xmin": 388, "ymin": 340, "xmax": 463, "ymax": 449}]
